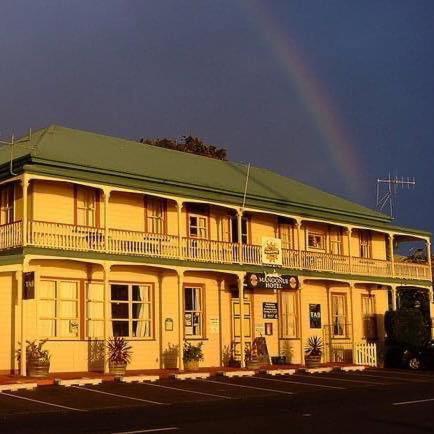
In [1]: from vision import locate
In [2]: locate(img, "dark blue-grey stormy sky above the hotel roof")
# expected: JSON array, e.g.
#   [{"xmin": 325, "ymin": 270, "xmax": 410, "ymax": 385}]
[{"xmin": 0, "ymin": 0, "xmax": 434, "ymax": 231}]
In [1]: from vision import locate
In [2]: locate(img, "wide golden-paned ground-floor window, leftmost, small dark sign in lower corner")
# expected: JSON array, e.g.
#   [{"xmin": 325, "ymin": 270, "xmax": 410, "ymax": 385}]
[{"xmin": 38, "ymin": 280, "xmax": 79, "ymax": 338}]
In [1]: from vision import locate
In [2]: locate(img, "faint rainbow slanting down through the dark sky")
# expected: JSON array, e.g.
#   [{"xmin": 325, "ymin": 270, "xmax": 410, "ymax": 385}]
[{"xmin": 243, "ymin": 0, "xmax": 364, "ymax": 198}]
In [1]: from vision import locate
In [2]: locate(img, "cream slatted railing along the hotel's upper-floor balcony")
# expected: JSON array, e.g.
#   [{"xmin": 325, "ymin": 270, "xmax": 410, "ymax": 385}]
[{"xmin": 0, "ymin": 220, "xmax": 431, "ymax": 280}]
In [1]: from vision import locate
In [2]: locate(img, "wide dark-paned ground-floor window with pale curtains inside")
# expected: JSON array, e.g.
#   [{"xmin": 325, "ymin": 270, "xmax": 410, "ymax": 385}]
[{"xmin": 110, "ymin": 284, "xmax": 152, "ymax": 338}]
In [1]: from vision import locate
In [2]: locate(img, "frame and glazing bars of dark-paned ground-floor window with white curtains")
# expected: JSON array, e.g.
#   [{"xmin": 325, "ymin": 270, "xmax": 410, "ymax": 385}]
[{"xmin": 108, "ymin": 281, "xmax": 155, "ymax": 341}]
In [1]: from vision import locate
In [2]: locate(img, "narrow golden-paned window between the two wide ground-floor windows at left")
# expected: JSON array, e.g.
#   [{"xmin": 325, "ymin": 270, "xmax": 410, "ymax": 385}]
[{"xmin": 86, "ymin": 282, "xmax": 104, "ymax": 338}]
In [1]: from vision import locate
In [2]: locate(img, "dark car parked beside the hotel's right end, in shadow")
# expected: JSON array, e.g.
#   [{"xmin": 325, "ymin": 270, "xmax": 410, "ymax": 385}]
[{"xmin": 385, "ymin": 340, "xmax": 434, "ymax": 369}]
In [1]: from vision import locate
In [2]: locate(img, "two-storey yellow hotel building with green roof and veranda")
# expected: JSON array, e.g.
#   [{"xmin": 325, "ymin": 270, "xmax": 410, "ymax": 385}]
[{"xmin": 0, "ymin": 126, "xmax": 433, "ymax": 374}]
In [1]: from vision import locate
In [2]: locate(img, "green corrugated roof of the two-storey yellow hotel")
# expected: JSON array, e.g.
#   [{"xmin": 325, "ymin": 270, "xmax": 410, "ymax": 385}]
[{"xmin": 0, "ymin": 125, "xmax": 430, "ymax": 236}]
